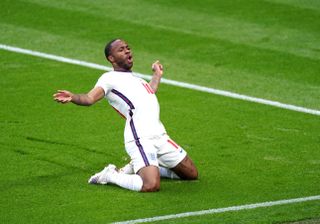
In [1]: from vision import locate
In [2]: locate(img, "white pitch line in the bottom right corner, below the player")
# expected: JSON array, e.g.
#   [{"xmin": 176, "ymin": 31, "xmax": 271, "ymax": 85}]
[{"xmin": 112, "ymin": 195, "xmax": 320, "ymax": 224}]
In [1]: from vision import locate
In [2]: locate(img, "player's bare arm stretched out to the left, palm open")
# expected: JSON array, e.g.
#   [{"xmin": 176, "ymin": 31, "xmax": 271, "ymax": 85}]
[{"xmin": 53, "ymin": 87, "xmax": 104, "ymax": 106}]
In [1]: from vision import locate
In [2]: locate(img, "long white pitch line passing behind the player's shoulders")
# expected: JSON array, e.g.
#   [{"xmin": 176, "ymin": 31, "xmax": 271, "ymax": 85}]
[{"xmin": 0, "ymin": 44, "xmax": 320, "ymax": 116}]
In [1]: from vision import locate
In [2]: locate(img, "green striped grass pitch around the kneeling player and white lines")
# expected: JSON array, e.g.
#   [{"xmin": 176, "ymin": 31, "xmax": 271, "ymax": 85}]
[{"xmin": 0, "ymin": 0, "xmax": 320, "ymax": 224}]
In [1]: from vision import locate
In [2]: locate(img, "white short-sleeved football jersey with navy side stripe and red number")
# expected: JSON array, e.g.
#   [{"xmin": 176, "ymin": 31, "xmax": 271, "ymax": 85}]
[{"xmin": 95, "ymin": 71, "xmax": 166, "ymax": 142}]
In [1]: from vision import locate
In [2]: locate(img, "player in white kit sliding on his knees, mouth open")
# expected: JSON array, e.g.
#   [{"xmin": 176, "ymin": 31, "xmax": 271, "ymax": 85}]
[{"xmin": 53, "ymin": 39, "xmax": 198, "ymax": 192}]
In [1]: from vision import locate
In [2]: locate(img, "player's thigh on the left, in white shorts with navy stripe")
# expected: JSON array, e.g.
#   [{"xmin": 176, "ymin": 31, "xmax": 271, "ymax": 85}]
[{"xmin": 125, "ymin": 139, "xmax": 159, "ymax": 173}]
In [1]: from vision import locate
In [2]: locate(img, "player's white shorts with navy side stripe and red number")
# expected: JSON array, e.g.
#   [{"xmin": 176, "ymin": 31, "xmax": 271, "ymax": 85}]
[{"xmin": 125, "ymin": 134, "xmax": 187, "ymax": 173}]
